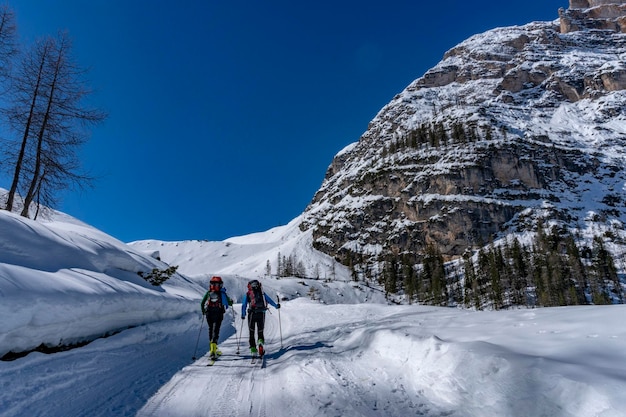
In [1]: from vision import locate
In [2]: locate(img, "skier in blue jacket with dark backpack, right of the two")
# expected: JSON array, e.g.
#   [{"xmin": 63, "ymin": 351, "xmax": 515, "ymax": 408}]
[{"xmin": 241, "ymin": 279, "xmax": 280, "ymax": 356}]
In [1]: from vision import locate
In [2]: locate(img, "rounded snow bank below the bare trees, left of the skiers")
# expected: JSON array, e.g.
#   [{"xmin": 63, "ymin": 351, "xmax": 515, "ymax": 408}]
[{"xmin": 0, "ymin": 199, "xmax": 202, "ymax": 356}]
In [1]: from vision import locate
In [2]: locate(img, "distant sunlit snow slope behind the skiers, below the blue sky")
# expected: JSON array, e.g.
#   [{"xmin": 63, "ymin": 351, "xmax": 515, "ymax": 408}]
[{"xmin": 129, "ymin": 217, "xmax": 387, "ymax": 304}]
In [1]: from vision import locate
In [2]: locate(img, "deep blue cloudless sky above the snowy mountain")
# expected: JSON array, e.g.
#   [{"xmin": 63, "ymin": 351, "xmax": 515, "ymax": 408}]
[{"xmin": 0, "ymin": 0, "xmax": 568, "ymax": 242}]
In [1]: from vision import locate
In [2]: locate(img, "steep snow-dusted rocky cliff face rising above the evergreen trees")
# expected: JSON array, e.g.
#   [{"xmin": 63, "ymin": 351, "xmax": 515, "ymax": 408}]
[{"xmin": 301, "ymin": 0, "xmax": 626, "ymax": 264}]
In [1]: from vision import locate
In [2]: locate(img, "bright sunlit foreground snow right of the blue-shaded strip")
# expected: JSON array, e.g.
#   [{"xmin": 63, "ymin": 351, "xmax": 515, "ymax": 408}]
[{"xmin": 138, "ymin": 299, "xmax": 626, "ymax": 417}]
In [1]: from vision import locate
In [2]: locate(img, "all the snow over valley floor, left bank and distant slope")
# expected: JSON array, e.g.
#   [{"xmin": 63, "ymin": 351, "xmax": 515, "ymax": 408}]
[{"xmin": 0, "ymin": 196, "xmax": 626, "ymax": 417}]
